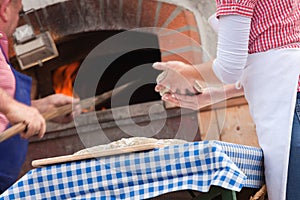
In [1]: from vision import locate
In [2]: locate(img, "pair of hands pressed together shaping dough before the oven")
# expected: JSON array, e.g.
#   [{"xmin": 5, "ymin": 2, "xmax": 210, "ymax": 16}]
[{"xmin": 153, "ymin": 61, "xmax": 233, "ymax": 110}]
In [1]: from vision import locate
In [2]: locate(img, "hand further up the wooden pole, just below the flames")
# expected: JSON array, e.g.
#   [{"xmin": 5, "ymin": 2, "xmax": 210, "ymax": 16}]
[{"xmin": 32, "ymin": 94, "xmax": 81, "ymax": 123}]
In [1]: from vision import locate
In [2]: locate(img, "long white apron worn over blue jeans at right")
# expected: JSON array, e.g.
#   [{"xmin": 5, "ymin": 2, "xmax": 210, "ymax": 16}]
[{"xmin": 241, "ymin": 49, "xmax": 300, "ymax": 200}]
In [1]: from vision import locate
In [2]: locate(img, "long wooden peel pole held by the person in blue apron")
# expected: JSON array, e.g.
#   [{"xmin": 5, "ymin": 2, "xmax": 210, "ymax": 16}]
[{"xmin": 0, "ymin": 82, "xmax": 133, "ymax": 142}]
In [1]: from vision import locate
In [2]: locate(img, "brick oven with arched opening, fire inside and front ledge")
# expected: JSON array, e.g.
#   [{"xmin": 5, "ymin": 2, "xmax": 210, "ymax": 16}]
[{"xmin": 10, "ymin": 0, "xmax": 213, "ymax": 173}]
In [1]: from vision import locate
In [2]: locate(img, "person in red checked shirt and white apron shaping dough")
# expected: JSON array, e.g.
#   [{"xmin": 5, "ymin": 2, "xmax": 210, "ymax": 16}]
[{"xmin": 153, "ymin": 0, "xmax": 300, "ymax": 200}]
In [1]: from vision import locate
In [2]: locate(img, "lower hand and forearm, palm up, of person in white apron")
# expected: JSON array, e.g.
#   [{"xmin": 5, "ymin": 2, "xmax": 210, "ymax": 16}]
[{"xmin": 162, "ymin": 84, "xmax": 243, "ymax": 110}]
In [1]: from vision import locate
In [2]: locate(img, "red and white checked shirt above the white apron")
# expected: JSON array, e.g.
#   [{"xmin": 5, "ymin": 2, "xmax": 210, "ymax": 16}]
[{"xmin": 216, "ymin": 0, "xmax": 300, "ymax": 91}]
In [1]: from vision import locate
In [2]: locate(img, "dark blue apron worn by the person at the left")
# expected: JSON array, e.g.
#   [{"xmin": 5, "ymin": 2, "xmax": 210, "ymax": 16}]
[{"xmin": 0, "ymin": 48, "xmax": 31, "ymax": 194}]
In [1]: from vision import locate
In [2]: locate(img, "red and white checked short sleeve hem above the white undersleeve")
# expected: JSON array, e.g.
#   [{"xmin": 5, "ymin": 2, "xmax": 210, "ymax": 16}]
[{"xmin": 216, "ymin": 0, "xmax": 258, "ymax": 17}]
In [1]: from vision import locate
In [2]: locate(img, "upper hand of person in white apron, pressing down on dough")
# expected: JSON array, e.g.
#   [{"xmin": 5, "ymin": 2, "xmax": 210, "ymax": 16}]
[{"xmin": 153, "ymin": 61, "xmax": 200, "ymax": 95}]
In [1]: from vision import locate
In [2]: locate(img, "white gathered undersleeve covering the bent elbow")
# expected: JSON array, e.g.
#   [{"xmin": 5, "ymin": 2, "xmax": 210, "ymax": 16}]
[{"xmin": 213, "ymin": 15, "xmax": 251, "ymax": 84}]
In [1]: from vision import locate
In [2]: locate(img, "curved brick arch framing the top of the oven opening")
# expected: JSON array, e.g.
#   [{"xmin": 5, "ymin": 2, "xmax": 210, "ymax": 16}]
[{"xmin": 11, "ymin": 0, "xmax": 202, "ymax": 63}]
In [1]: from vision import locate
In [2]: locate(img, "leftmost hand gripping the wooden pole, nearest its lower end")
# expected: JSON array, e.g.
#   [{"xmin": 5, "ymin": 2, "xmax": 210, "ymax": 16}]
[{"xmin": 4, "ymin": 101, "xmax": 46, "ymax": 139}]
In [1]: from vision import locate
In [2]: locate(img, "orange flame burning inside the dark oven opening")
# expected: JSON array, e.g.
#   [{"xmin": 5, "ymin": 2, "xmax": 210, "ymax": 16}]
[{"xmin": 52, "ymin": 62, "xmax": 80, "ymax": 96}]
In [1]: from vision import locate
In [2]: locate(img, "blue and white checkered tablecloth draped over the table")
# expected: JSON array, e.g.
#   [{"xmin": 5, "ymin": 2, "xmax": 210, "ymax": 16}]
[{"xmin": 0, "ymin": 141, "xmax": 264, "ymax": 200}]
